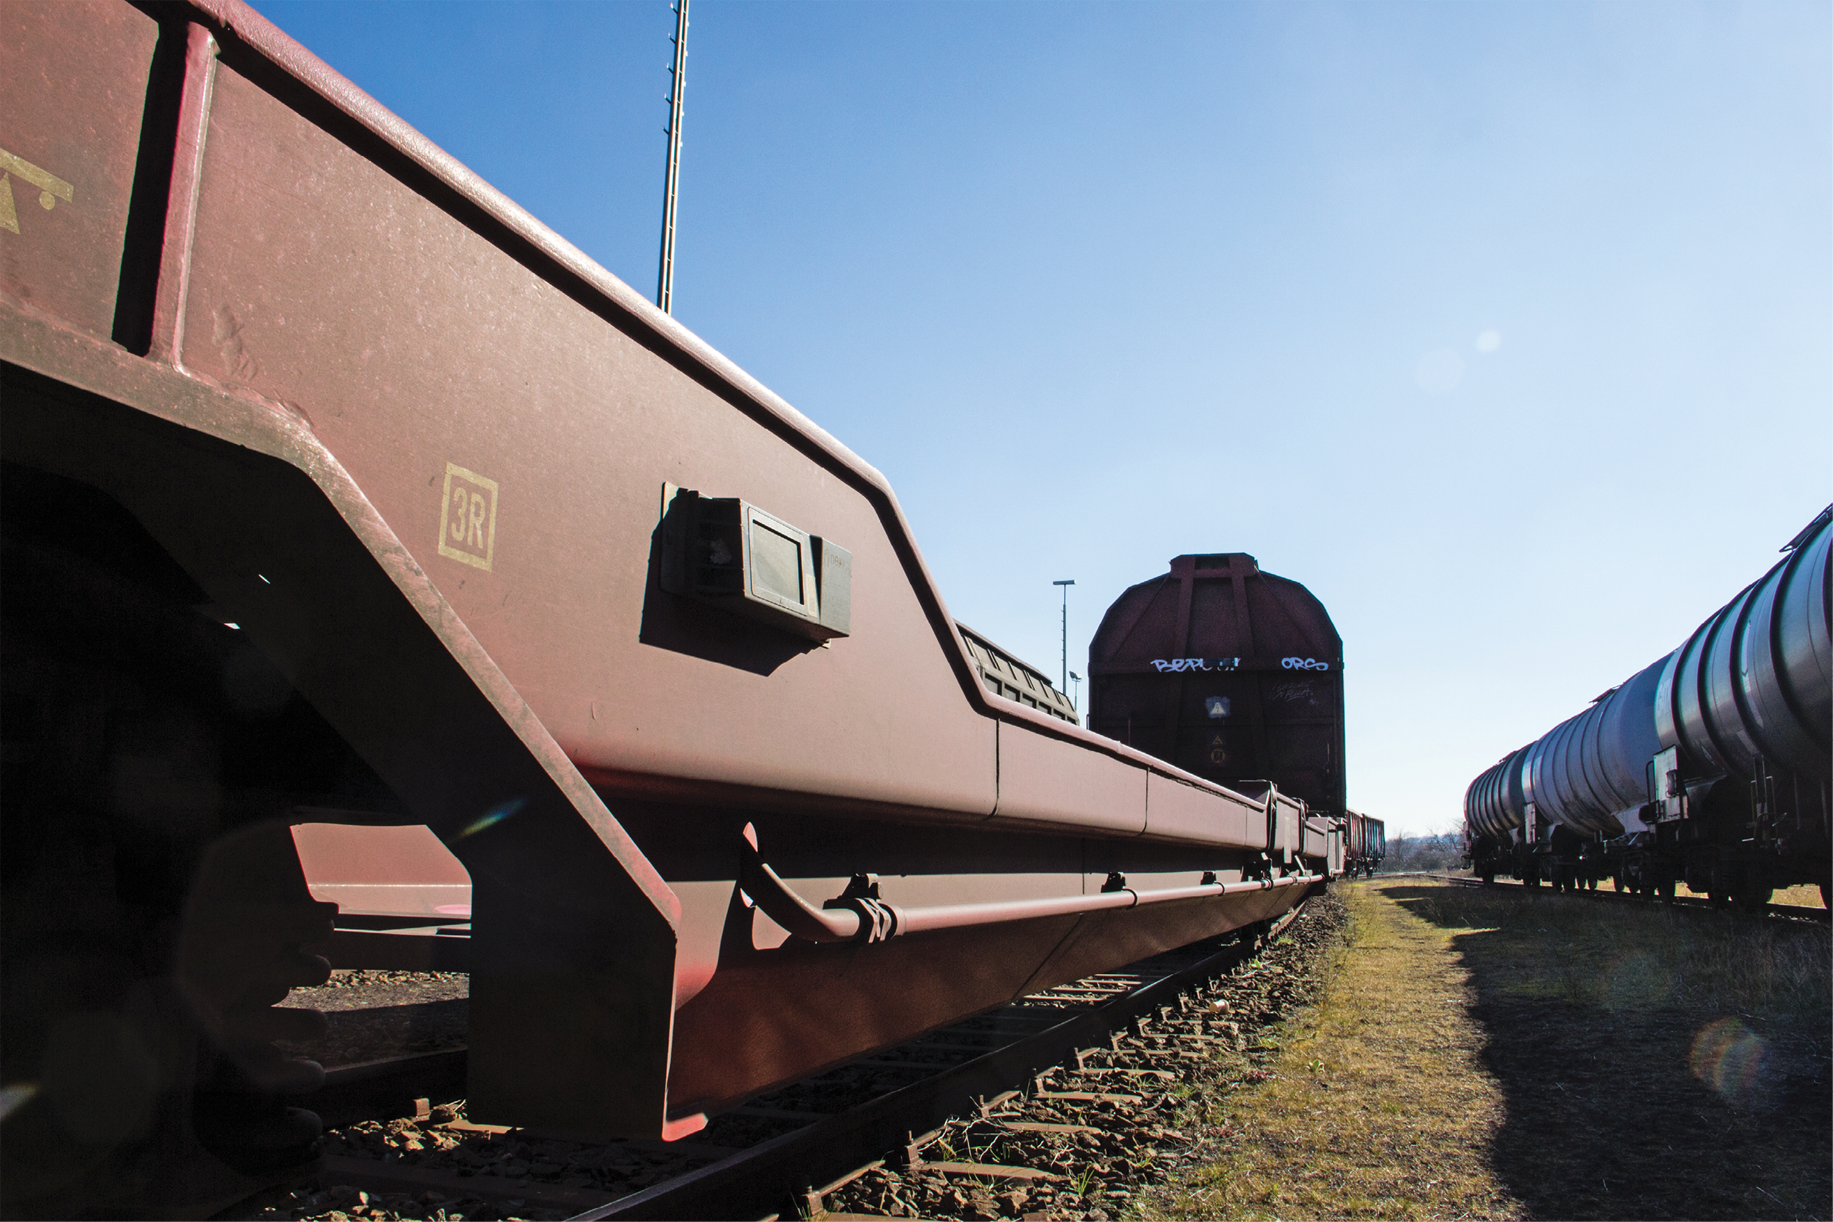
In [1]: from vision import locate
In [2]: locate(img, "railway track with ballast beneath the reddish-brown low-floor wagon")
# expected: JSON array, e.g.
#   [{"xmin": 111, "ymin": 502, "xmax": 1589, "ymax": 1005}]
[{"xmin": 247, "ymin": 890, "xmax": 1334, "ymax": 1222}]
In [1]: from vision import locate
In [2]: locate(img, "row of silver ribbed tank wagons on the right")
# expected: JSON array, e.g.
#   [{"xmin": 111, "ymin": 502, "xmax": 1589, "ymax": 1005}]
[{"xmin": 1465, "ymin": 506, "xmax": 1833, "ymax": 909}]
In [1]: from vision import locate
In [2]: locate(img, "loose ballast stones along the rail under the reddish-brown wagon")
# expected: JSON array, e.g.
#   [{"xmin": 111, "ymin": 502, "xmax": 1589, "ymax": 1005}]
[{"xmin": 229, "ymin": 892, "xmax": 1344, "ymax": 1222}]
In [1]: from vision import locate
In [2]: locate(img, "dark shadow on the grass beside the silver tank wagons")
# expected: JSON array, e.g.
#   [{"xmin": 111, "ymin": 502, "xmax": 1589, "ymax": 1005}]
[{"xmin": 1382, "ymin": 885, "xmax": 1833, "ymax": 1222}]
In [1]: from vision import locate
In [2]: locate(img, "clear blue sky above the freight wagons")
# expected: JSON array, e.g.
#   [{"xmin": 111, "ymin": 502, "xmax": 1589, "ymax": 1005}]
[{"xmin": 258, "ymin": 0, "xmax": 1833, "ymax": 834}]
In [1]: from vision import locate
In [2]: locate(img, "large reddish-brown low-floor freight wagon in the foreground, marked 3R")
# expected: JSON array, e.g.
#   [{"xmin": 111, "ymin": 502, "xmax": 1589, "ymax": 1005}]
[{"xmin": 0, "ymin": 0, "xmax": 1342, "ymax": 1217}]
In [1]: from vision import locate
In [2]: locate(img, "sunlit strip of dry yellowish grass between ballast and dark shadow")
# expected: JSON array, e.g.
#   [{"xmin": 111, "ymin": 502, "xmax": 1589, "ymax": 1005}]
[{"xmin": 1138, "ymin": 887, "xmax": 1525, "ymax": 1220}]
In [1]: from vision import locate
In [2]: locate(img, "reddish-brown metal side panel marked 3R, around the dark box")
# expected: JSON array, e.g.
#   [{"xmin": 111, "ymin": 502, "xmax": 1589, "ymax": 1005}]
[{"xmin": 0, "ymin": 4, "xmax": 1268, "ymax": 850}]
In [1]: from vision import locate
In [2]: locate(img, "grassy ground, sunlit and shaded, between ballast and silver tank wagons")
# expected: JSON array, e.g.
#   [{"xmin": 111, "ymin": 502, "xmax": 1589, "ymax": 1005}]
[{"xmin": 1146, "ymin": 878, "xmax": 1833, "ymax": 1222}]
